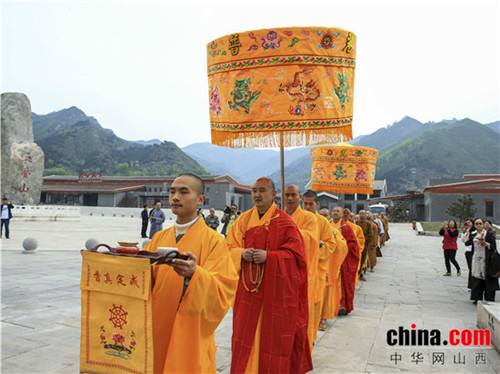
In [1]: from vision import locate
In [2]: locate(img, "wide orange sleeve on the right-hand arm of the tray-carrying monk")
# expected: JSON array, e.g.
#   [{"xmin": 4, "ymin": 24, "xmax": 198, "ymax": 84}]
[{"xmin": 179, "ymin": 237, "xmax": 238, "ymax": 331}]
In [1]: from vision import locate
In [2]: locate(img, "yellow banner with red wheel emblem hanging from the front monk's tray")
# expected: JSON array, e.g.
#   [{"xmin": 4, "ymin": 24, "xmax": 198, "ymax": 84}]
[{"xmin": 80, "ymin": 251, "xmax": 154, "ymax": 374}]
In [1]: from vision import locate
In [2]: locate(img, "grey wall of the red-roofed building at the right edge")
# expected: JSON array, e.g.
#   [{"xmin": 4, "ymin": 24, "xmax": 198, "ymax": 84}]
[{"xmin": 424, "ymin": 192, "xmax": 500, "ymax": 223}]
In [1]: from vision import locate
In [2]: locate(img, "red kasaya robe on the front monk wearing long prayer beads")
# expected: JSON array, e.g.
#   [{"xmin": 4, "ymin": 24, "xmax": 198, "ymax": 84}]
[{"xmin": 231, "ymin": 204, "xmax": 312, "ymax": 374}]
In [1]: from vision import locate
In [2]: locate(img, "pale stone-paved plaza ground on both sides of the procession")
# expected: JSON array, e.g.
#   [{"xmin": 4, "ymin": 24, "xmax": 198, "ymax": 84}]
[{"xmin": 1, "ymin": 213, "xmax": 500, "ymax": 373}]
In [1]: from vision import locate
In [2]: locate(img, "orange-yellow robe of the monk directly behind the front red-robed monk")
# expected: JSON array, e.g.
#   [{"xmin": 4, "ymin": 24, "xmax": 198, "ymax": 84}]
[{"xmin": 292, "ymin": 206, "xmax": 319, "ymax": 352}]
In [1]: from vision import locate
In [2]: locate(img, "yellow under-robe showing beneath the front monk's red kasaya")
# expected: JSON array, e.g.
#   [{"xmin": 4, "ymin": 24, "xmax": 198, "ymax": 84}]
[{"xmin": 226, "ymin": 203, "xmax": 276, "ymax": 373}]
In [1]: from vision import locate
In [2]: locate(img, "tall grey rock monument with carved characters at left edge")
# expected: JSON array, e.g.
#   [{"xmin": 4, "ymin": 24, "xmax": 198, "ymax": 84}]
[{"xmin": 0, "ymin": 92, "xmax": 44, "ymax": 205}]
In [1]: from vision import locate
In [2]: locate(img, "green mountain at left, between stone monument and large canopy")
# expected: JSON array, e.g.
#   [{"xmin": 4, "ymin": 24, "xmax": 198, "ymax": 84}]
[{"xmin": 32, "ymin": 107, "xmax": 206, "ymax": 176}]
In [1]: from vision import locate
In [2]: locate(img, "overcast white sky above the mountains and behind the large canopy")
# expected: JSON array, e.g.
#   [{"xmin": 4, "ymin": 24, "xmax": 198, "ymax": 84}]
[{"xmin": 1, "ymin": 0, "xmax": 500, "ymax": 147}]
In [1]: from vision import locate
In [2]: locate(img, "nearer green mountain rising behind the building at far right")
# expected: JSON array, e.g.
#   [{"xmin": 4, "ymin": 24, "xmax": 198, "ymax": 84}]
[{"xmin": 376, "ymin": 118, "xmax": 500, "ymax": 192}]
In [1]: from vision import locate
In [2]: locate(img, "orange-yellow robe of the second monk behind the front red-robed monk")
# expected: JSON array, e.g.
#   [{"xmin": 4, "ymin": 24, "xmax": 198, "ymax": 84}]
[{"xmin": 313, "ymin": 212, "xmax": 337, "ymax": 339}]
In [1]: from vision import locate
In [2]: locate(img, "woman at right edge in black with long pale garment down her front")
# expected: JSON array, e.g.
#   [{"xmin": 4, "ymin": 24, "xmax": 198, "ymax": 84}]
[{"xmin": 465, "ymin": 219, "xmax": 499, "ymax": 304}]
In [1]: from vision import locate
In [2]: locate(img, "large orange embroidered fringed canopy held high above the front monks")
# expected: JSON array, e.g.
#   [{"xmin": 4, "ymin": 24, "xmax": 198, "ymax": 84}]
[{"xmin": 207, "ymin": 27, "xmax": 356, "ymax": 147}]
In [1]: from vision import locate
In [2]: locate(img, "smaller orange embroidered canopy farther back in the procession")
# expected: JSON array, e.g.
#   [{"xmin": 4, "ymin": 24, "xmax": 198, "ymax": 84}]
[{"xmin": 311, "ymin": 143, "xmax": 378, "ymax": 194}]
